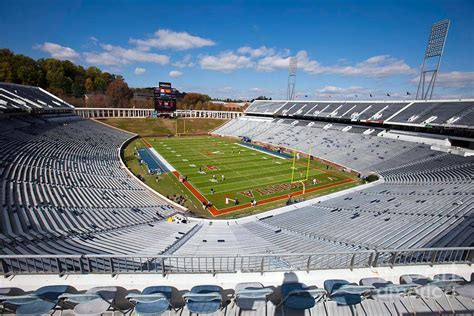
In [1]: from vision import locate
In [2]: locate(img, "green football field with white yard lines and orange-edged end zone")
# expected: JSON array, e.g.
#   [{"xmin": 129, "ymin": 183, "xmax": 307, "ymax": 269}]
[{"xmin": 147, "ymin": 136, "xmax": 355, "ymax": 211}]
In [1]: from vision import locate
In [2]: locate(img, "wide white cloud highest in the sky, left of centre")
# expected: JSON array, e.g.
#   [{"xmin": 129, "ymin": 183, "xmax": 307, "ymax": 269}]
[{"xmin": 130, "ymin": 29, "xmax": 215, "ymax": 50}]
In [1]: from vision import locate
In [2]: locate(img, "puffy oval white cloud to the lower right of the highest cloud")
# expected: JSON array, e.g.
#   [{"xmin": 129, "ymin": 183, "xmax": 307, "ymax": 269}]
[{"xmin": 199, "ymin": 51, "xmax": 253, "ymax": 73}]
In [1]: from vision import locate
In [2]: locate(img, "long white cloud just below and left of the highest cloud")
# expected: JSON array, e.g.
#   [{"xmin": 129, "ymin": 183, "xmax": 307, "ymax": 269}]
[{"xmin": 84, "ymin": 44, "xmax": 170, "ymax": 66}]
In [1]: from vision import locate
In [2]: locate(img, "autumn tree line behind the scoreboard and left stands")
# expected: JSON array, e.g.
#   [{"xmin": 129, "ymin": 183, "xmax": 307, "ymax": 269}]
[{"xmin": 0, "ymin": 48, "xmax": 248, "ymax": 110}]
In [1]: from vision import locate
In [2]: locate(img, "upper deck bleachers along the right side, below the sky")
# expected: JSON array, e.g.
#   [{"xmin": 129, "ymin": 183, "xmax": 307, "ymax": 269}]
[{"xmin": 245, "ymin": 100, "xmax": 474, "ymax": 127}]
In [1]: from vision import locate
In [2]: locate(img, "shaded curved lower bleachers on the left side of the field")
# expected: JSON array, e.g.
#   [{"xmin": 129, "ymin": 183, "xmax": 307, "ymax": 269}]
[{"xmin": 0, "ymin": 121, "xmax": 192, "ymax": 254}]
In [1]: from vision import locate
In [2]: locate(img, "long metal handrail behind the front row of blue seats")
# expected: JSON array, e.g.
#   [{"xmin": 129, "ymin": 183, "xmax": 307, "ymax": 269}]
[{"xmin": 0, "ymin": 247, "xmax": 474, "ymax": 275}]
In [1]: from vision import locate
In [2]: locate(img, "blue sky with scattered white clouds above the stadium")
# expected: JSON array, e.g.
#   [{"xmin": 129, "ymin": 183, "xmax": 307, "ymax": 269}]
[{"xmin": 0, "ymin": 0, "xmax": 474, "ymax": 99}]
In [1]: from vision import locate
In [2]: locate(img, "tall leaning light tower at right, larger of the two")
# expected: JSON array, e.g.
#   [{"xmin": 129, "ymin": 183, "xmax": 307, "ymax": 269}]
[{"xmin": 416, "ymin": 20, "xmax": 450, "ymax": 100}]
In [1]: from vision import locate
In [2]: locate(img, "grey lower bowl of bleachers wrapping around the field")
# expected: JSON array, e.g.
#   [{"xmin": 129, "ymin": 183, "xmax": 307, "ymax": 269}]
[{"xmin": 0, "ymin": 88, "xmax": 474, "ymax": 286}]
